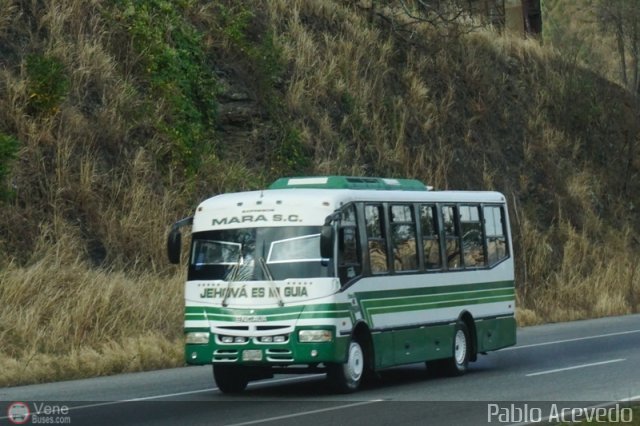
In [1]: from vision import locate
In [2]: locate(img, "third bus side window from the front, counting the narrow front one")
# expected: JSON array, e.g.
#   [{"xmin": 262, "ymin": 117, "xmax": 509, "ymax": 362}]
[{"xmin": 391, "ymin": 204, "xmax": 418, "ymax": 271}]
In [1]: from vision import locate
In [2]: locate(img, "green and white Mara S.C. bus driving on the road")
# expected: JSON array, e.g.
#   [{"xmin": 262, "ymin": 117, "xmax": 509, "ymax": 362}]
[{"xmin": 167, "ymin": 176, "xmax": 516, "ymax": 392}]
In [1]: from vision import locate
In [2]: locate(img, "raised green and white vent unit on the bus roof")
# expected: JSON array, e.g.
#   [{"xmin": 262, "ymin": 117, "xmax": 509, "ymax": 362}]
[{"xmin": 269, "ymin": 176, "xmax": 433, "ymax": 191}]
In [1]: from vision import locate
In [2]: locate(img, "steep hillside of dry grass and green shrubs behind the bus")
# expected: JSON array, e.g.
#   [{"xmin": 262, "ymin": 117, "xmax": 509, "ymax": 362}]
[{"xmin": 0, "ymin": 0, "xmax": 640, "ymax": 386}]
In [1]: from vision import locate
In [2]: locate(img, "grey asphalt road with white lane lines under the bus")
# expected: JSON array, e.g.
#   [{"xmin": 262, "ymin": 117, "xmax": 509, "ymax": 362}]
[{"xmin": 0, "ymin": 315, "xmax": 640, "ymax": 426}]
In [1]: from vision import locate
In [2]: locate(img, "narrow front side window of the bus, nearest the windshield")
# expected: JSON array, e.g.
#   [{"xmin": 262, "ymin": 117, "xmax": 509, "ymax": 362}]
[{"xmin": 338, "ymin": 204, "xmax": 362, "ymax": 284}]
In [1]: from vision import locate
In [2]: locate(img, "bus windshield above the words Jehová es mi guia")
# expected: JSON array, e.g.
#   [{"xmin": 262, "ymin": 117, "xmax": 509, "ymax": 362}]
[{"xmin": 188, "ymin": 226, "xmax": 329, "ymax": 281}]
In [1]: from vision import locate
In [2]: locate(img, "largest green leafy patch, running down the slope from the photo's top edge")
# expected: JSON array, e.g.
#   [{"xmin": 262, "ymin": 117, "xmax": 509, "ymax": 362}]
[{"xmin": 110, "ymin": 0, "xmax": 218, "ymax": 177}]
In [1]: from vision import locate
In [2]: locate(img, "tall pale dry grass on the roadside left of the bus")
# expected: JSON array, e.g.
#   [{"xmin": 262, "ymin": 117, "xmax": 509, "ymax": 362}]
[{"xmin": 0, "ymin": 235, "xmax": 184, "ymax": 386}]
